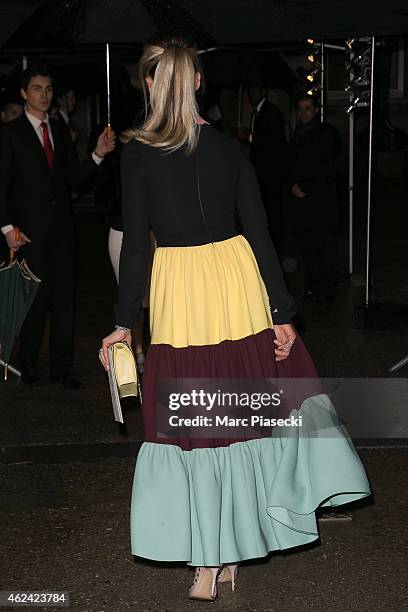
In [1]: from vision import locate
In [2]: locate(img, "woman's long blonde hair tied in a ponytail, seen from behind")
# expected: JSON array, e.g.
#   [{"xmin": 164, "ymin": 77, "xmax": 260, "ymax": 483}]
[{"xmin": 124, "ymin": 36, "xmax": 202, "ymax": 154}]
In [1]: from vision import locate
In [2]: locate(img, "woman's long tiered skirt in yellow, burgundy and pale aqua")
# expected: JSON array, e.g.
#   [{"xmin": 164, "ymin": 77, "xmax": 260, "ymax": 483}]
[{"xmin": 131, "ymin": 235, "xmax": 370, "ymax": 566}]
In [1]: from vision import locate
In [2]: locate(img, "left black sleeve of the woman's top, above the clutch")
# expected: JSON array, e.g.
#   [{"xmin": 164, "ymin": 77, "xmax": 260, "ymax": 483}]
[{"xmin": 115, "ymin": 141, "xmax": 150, "ymax": 327}]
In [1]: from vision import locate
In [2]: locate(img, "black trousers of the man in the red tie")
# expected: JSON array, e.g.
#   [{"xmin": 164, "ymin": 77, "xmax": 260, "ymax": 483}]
[{"xmin": 19, "ymin": 232, "xmax": 75, "ymax": 376}]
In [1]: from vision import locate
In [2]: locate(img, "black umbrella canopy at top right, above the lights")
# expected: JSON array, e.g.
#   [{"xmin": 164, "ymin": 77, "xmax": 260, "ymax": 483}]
[{"xmin": 177, "ymin": 0, "xmax": 408, "ymax": 45}]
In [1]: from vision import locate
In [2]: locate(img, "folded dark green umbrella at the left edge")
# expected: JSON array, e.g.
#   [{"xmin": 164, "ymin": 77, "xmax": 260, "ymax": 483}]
[{"xmin": 0, "ymin": 260, "xmax": 41, "ymax": 380}]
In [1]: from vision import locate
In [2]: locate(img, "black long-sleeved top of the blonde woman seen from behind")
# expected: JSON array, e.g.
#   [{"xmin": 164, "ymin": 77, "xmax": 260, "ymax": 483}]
[{"xmin": 116, "ymin": 125, "xmax": 296, "ymax": 327}]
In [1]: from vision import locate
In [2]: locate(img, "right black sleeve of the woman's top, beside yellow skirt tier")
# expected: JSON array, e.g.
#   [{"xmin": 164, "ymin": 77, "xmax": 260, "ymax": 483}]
[{"xmin": 237, "ymin": 154, "xmax": 296, "ymax": 325}]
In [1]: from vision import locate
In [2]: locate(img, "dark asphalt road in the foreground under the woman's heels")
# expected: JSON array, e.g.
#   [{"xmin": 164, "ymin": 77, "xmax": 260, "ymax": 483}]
[{"xmin": 0, "ymin": 449, "xmax": 408, "ymax": 612}]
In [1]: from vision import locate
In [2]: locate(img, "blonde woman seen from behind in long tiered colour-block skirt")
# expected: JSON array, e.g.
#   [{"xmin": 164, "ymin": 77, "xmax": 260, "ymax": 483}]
[{"xmin": 100, "ymin": 37, "xmax": 370, "ymax": 601}]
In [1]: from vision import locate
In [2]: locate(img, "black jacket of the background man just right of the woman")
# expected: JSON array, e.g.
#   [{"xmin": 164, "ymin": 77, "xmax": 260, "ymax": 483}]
[{"xmin": 250, "ymin": 100, "xmax": 288, "ymax": 180}]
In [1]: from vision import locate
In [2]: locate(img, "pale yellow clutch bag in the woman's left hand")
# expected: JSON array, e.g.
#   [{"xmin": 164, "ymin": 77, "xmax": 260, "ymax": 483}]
[{"xmin": 108, "ymin": 342, "xmax": 140, "ymax": 423}]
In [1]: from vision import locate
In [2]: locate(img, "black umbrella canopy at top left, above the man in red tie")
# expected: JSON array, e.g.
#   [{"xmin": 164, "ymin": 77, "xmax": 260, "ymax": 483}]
[{"xmin": 4, "ymin": 0, "xmax": 215, "ymax": 51}]
